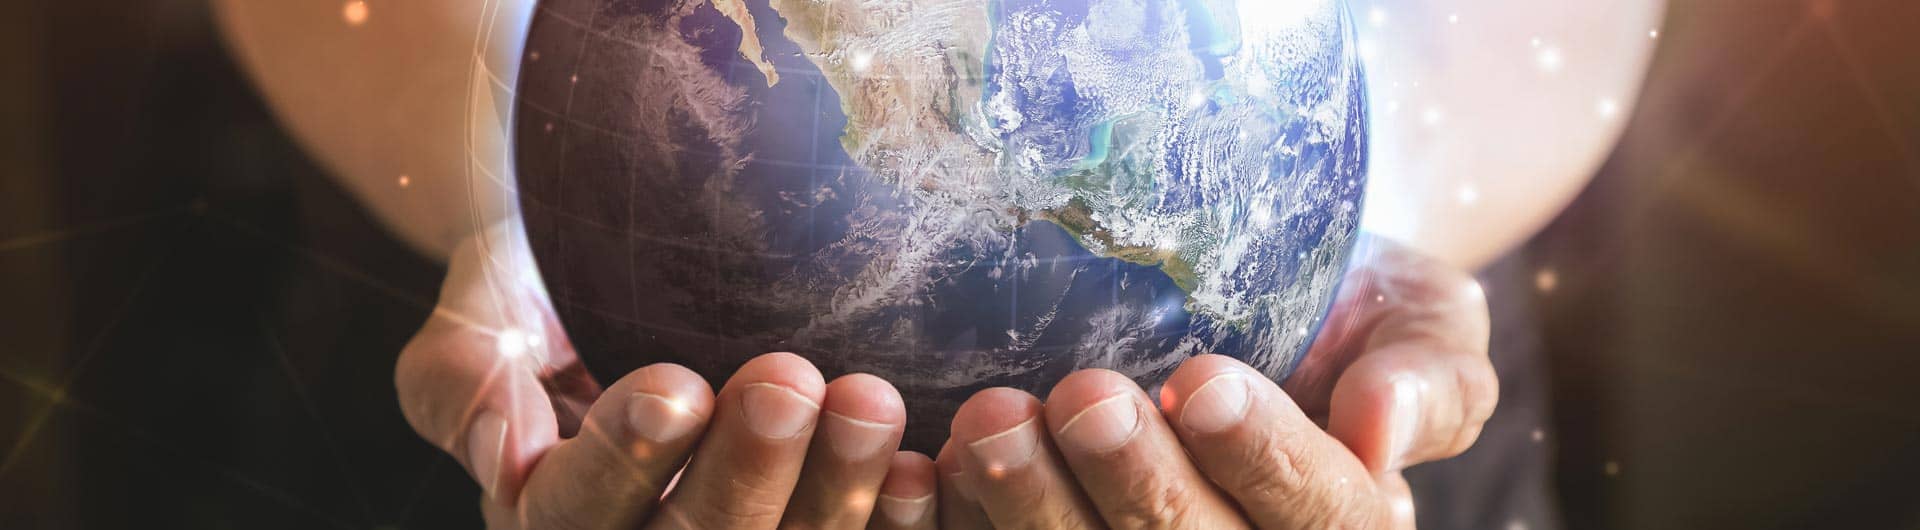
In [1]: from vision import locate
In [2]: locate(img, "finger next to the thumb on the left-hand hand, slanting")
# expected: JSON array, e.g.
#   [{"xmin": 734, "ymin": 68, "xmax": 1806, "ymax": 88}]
[{"xmin": 520, "ymin": 365, "xmax": 714, "ymax": 528}]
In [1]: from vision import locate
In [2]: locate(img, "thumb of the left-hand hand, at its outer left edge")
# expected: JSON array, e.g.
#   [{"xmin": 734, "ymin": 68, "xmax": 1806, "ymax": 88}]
[{"xmin": 394, "ymin": 317, "xmax": 561, "ymax": 507}]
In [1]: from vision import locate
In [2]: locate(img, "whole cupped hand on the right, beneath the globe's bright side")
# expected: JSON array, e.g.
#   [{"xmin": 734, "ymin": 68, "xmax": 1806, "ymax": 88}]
[{"xmin": 939, "ymin": 238, "xmax": 1498, "ymax": 528}]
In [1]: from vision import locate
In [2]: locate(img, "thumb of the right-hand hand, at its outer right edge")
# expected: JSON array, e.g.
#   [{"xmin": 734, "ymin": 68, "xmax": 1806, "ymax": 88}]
[{"xmin": 1286, "ymin": 238, "xmax": 1500, "ymax": 472}]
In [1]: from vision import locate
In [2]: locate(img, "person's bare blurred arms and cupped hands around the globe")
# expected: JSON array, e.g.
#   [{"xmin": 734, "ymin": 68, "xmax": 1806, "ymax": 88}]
[{"xmin": 213, "ymin": 0, "xmax": 1661, "ymax": 528}]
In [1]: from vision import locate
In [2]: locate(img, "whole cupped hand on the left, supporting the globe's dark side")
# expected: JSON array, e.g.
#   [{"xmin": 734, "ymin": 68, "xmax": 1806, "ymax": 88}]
[{"xmin": 394, "ymin": 225, "xmax": 935, "ymax": 528}]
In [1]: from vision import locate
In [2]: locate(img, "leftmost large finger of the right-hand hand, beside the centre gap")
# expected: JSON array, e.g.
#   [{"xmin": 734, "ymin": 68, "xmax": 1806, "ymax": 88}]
[{"xmin": 952, "ymin": 388, "xmax": 1104, "ymax": 528}]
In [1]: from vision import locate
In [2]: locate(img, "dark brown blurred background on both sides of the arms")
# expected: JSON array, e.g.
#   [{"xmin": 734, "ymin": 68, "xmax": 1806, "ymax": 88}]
[{"xmin": 0, "ymin": 0, "xmax": 1920, "ymax": 528}]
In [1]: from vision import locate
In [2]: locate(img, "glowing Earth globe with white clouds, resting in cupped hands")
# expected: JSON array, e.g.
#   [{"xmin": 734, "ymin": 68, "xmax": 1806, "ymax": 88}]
[{"xmin": 513, "ymin": 0, "xmax": 1367, "ymax": 451}]
